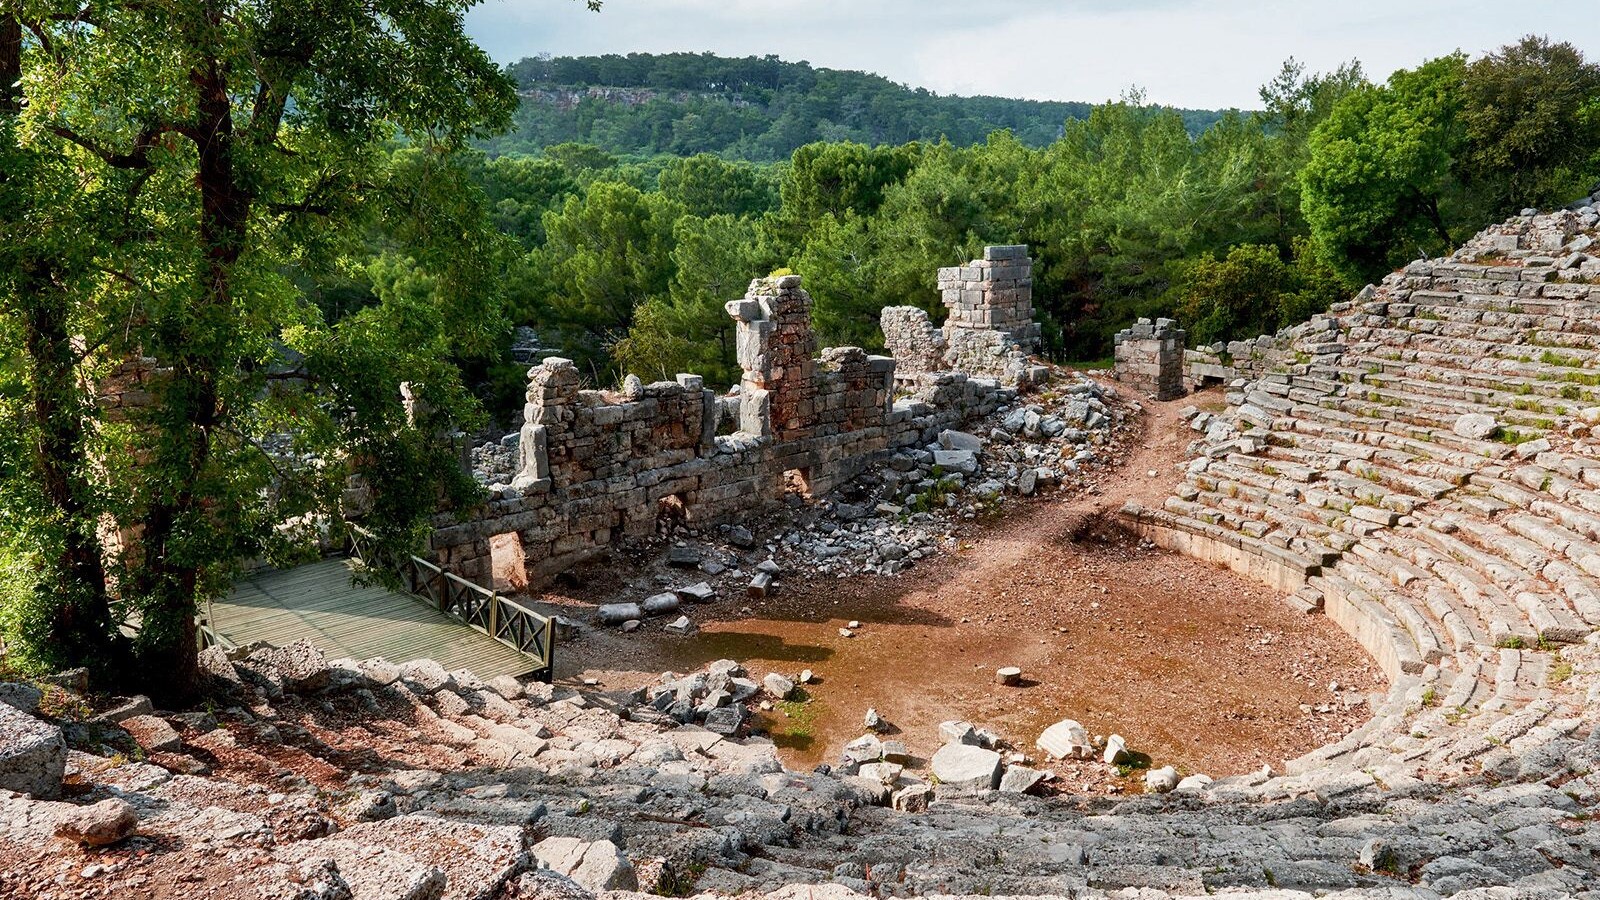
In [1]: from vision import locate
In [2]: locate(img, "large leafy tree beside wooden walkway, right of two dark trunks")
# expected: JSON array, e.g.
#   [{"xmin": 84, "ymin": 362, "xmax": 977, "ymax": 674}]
[{"xmin": 8, "ymin": 0, "xmax": 515, "ymax": 700}]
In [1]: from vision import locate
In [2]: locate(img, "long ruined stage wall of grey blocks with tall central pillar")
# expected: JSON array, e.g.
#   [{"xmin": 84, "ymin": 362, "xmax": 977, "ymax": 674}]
[{"xmin": 430, "ymin": 275, "xmax": 1016, "ymax": 583}]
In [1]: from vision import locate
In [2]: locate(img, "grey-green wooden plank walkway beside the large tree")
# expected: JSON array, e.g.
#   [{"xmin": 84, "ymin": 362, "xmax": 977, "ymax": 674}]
[{"xmin": 211, "ymin": 559, "xmax": 538, "ymax": 679}]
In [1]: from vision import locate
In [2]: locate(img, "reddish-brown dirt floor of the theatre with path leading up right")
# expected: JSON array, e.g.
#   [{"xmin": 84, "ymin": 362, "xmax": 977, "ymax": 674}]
[{"xmin": 534, "ymin": 389, "xmax": 1381, "ymax": 791}]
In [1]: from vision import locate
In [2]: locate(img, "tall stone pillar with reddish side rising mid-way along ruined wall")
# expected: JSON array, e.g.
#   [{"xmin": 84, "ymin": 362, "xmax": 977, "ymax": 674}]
[{"xmin": 726, "ymin": 275, "xmax": 816, "ymax": 440}]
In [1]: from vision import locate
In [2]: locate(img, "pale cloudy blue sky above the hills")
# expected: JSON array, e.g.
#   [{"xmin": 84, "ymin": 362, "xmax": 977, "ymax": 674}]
[{"xmin": 467, "ymin": 0, "xmax": 1600, "ymax": 107}]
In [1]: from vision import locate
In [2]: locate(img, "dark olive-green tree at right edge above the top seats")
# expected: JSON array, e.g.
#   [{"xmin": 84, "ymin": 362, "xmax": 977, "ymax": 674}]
[{"xmin": 1461, "ymin": 35, "xmax": 1600, "ymax": 215}]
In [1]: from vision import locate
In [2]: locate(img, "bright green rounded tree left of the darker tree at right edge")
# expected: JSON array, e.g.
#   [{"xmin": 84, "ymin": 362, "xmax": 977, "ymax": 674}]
[{"xmin": 1301, "ymin": 54, "xmax": 1467, "ymax": 279}]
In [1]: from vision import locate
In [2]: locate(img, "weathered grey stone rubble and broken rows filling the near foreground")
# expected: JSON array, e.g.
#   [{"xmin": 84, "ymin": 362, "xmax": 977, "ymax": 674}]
[{"xmin": 0, "ymin": 637, "xmax": 1600, "ymax": 900}]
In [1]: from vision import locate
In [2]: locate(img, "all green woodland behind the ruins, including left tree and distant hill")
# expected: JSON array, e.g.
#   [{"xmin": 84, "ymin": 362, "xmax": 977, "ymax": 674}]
[{"xmin": 0, "ymin": 0, "xmax": 1600, "ymax": 703}]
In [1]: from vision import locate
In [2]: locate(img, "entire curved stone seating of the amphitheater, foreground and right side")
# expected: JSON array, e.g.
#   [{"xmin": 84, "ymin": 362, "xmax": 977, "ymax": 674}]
[{"xmin": 0, "ymin": 204, "xmax": 1600, "ymax": 900}]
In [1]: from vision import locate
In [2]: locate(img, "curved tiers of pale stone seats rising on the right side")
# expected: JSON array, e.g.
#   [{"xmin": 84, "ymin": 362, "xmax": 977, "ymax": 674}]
[{"xmin": 1123, "ymin": 207, "xmax": 1600, "ymax": 783}]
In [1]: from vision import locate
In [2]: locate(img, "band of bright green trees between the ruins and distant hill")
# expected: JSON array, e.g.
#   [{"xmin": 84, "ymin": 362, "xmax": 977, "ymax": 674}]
[{"xmin": 472, "ymin": 38, "xmax": 1600, "ymax": 398}]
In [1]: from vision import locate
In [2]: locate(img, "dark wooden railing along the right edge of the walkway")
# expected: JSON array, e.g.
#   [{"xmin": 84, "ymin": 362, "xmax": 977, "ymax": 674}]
[{"xmin": 350, "ymin": 525, "xmax": 555, "ymax": 682}]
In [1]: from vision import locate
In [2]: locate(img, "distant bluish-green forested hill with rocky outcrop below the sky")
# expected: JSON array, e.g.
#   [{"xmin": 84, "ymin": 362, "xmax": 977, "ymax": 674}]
[{"xmin": 485, "ymin": 53, "xmax": 1221, "ymax": 162}]
